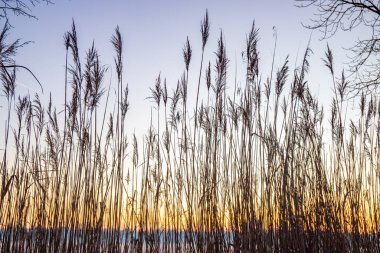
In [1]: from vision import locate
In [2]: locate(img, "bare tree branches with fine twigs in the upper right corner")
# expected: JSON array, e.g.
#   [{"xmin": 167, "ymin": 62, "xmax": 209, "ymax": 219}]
[{"xmin": 295, "ymin": 0, "xmax": 380, "ymax": 92}]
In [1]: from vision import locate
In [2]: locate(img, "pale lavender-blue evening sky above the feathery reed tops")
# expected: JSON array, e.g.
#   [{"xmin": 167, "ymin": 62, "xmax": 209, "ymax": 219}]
[{"xmin": 0, "ymin": 0, "xmax": 365, "ymax": 142}]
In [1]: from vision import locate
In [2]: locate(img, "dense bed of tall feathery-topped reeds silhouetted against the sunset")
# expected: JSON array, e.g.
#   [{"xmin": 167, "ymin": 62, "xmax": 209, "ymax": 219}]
[{"xmin": 0, "ymin": 13, "xmax": 380, "ymax": 253}]
